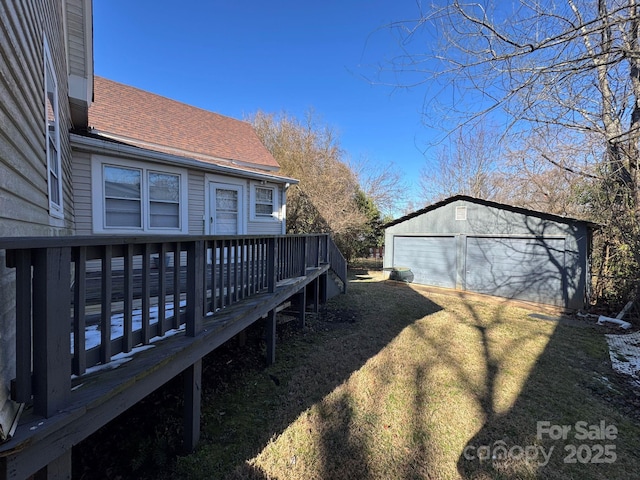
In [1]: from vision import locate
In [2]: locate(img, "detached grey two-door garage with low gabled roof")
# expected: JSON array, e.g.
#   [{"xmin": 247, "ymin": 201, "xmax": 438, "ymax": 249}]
[{"xmin": 384, "ymin": 195, "xmax": 594, "ymax": 309}]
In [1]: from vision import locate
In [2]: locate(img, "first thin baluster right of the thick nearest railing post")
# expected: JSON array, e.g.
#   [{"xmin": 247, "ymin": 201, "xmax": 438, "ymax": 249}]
[{"xmin": 73, "ymin": 247, "xmax": 87, "ymax": 375}]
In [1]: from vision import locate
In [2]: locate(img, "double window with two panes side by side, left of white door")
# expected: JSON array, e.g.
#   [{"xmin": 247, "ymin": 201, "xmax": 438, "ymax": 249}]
[{"xmin": 92, "ymin": 157, "xmax": 187, "ymax": 233}]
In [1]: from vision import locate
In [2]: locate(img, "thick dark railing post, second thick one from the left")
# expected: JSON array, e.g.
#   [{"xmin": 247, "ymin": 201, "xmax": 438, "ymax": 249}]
[{"xmin": 186, "ymin": 240, "xmax": 206, "ymax": 337}]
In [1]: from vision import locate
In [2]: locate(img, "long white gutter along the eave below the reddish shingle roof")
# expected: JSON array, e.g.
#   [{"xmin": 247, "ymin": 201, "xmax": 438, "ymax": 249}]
[{"xmin": 69, "ymin": 133, "xmax": 299, "ymax": 185}]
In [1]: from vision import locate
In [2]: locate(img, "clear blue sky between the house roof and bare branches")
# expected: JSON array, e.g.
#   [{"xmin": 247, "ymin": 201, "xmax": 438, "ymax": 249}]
[{"xmin": 94, "ymin": 0, "xmax": 432, "ymax": 204}]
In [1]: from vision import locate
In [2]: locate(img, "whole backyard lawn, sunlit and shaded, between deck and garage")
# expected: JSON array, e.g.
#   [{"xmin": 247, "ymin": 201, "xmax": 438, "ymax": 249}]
[{"xmin": 165, "ymin": 270, "xmax": 640, "ymax": 479}]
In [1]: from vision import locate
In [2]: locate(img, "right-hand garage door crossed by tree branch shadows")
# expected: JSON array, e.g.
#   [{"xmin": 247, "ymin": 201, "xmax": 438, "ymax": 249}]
[{"xmin": 466, "ymin": 237, "xmax": 564, "ymax": 305}]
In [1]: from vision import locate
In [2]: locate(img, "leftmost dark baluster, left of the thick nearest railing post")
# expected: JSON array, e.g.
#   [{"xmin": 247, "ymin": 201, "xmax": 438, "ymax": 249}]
[{"xmin": 15, "ymin": 250, "xmax": 32, "ymax": 403}]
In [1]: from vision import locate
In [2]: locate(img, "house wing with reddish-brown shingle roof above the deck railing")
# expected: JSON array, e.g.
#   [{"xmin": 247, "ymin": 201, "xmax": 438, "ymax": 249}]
[{"xmin": 75, "ymin": 76, "xmax": 297, "ymax": 235}]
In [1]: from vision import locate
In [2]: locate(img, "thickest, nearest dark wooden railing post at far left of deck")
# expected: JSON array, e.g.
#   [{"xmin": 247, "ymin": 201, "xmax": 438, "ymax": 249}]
[{"xmin": 33, "ymin": 247, "xmax": 71, "ymax": 418}]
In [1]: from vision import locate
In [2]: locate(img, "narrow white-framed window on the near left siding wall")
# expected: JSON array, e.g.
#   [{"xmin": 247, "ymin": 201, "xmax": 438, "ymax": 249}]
[{"xmin": 43, "ymin": 35, "xmax": 64, "ymax": 218}]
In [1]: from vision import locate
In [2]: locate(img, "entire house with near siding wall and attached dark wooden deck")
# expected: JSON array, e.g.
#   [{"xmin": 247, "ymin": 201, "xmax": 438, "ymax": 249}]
[{"xmin": 0, "ymin": 0, "xmax": 346, "ymax": 480}]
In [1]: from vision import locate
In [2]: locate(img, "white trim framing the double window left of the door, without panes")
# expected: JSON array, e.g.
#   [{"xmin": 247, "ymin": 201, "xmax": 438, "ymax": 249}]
[{"xmin": 91, "ymin": 155, "xmax": 189, "ymax": 235}]
